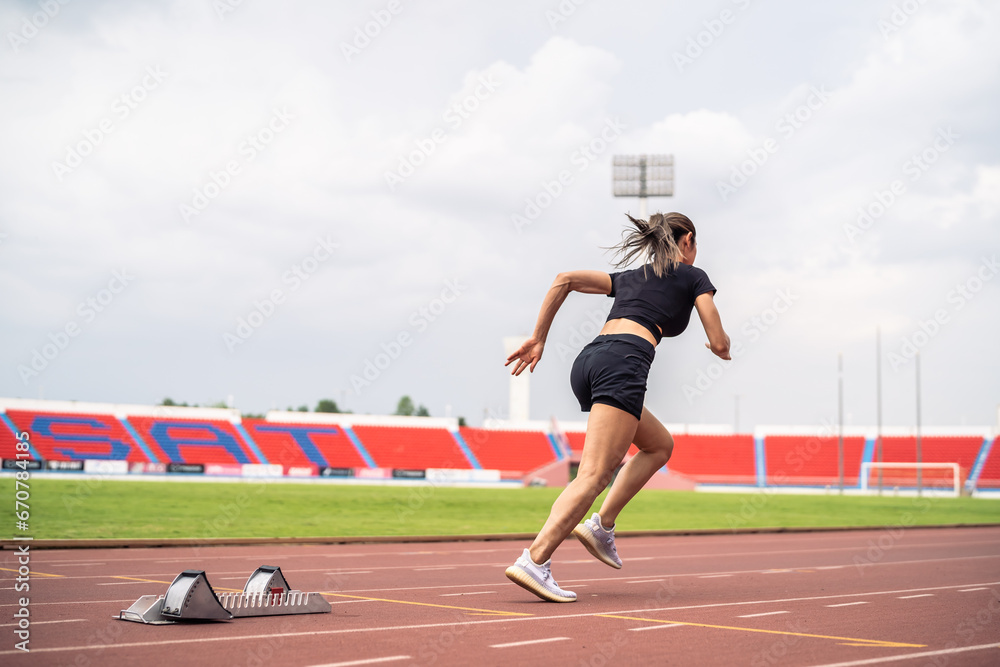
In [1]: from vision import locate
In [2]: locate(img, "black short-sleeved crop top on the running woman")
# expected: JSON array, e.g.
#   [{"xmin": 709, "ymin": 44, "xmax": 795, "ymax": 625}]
[{"xmin": 608, "ymin": 264, "xmax": 716, "ymax": 343}]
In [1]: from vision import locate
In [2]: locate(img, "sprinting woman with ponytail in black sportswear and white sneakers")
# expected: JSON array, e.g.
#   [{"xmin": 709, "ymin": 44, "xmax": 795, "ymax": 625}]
[{"xmin": 506, "ymin": 213, "xmax": 730, "ymax": 602}]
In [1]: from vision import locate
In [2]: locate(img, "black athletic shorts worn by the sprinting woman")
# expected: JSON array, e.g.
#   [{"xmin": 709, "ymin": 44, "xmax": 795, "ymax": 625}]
[{"xmin": 569, "ymin": 334, "xmax": 656, "ymax": 419}]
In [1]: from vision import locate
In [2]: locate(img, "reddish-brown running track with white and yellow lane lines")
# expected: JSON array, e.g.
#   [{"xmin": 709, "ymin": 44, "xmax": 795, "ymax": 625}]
[{"xmin": 0, "ymin": 527, "xmax": 1000, "ymax": 667}]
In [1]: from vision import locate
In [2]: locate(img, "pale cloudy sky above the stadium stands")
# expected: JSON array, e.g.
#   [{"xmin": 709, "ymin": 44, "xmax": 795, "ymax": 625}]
[{"xmin": 0, "ymin": 0, "xmax": 1000, "ymax": 430}]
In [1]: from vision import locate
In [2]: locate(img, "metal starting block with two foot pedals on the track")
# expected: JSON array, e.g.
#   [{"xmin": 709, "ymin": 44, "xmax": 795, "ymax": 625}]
[{"xmin": 118, "ymin": 565, "xmax": 331, "ymax": 625}]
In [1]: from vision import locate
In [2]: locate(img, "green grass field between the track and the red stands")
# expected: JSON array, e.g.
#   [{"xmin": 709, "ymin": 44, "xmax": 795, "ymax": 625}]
[{"xmin": 0, "ymin": 478, "xmax": 1000, "ymax": 539}]
